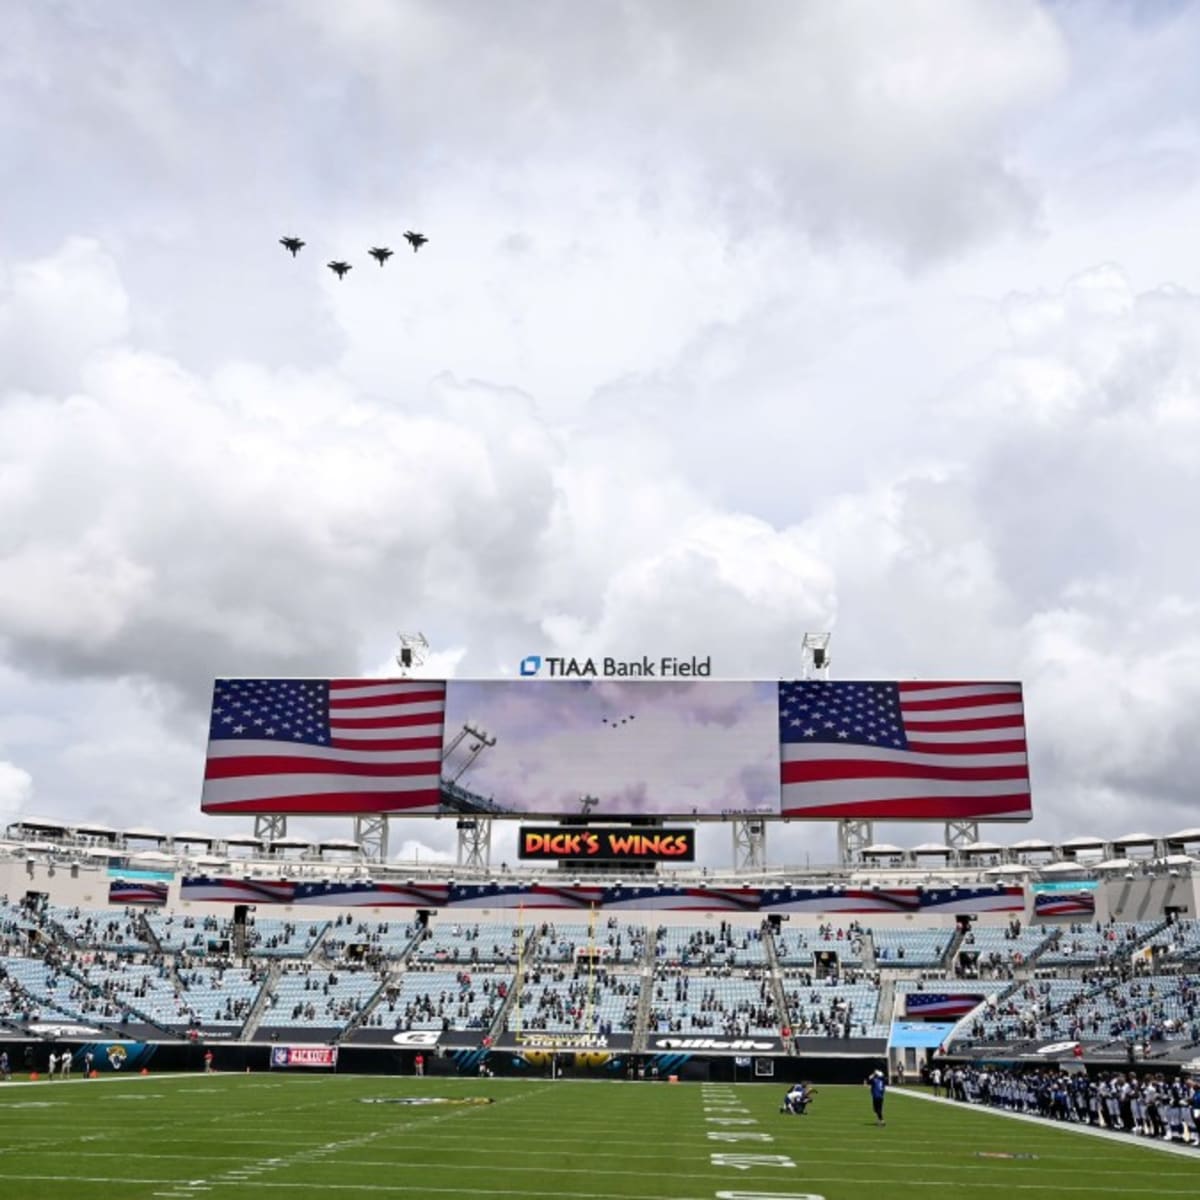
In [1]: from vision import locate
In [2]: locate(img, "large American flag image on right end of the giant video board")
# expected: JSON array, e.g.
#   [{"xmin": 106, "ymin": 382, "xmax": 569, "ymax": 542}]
[{"xmin": 779, "ymin": 679, "xmax": 1032, "ymax": 821}]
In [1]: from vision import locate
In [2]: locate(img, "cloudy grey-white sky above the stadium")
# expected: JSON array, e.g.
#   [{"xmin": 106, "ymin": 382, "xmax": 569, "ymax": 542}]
[{"xmin": 0, "ymin": 0, "xmax": 1200, "ymax": 862}]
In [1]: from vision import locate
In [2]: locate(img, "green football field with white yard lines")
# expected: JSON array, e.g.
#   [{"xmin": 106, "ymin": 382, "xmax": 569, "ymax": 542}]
[{"xmin": 0, "ymin": 1074, "xmax": 1200, "ymax": 1200}]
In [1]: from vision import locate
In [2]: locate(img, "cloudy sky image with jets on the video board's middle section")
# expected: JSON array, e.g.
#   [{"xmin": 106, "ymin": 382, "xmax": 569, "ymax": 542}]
[{"xmin": 445, "ymin": 679, "xmax": 779, "ymax": 818}]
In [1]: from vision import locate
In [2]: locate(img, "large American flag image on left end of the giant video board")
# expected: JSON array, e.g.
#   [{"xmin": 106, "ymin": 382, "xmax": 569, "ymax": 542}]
[{"xmin": 200, "ymin": 679, "xmax": 445, "ymax": 815}]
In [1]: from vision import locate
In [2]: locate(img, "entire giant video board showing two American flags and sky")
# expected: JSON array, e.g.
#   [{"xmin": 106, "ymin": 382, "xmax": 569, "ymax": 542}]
[{"xmin": 202, "ymin": 671, "xmax": 1032, "ymax": 821}]
